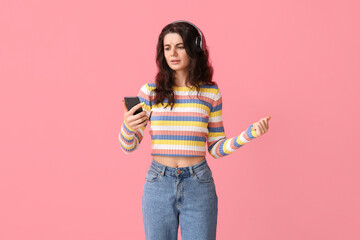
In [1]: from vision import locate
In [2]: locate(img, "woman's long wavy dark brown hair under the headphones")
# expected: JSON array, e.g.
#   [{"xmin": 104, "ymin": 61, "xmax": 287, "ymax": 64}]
[{"xmin": 153, "ymin": 22, "xmax": 217, "ymax": 110}]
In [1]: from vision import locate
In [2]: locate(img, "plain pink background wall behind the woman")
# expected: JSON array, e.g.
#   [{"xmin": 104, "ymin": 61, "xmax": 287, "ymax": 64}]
[{"xmin": 0, "ymin": 0, "xmax": 360, "ymax": 240}]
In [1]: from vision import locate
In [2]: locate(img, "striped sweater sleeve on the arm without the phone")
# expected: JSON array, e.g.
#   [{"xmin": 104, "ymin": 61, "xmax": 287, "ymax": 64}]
[{"xmin": 207, "ymin": 89, "xmax": 258, "ymax": 158}]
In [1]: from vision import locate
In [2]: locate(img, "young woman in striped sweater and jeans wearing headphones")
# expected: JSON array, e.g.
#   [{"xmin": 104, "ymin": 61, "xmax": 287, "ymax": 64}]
[{"xmin": 119, "ymin": 21, "xmax": 270, "ymax": 240}]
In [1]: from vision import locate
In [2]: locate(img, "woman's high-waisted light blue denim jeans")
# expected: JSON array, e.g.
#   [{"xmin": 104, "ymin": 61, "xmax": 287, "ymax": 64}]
[{"xmin": 142, "ymin": 158, "xmax": 218, "ymax": 240}]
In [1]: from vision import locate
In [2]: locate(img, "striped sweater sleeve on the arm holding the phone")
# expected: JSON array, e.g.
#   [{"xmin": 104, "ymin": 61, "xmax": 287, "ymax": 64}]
[{"xmin": 118, "ymin": 84, "xmax": 151, "ymax": 154}]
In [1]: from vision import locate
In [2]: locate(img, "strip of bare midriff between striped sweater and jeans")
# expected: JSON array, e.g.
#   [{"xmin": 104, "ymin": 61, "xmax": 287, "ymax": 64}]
[{"xmin": 152, "ymin": 155, "xmax": 205, "ymax": 168}]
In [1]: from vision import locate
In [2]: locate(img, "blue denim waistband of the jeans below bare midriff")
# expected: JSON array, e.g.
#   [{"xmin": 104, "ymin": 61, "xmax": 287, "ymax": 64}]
[{"xmin": 150, "ymin": 157, "xmax": 208, "ymax": 177}]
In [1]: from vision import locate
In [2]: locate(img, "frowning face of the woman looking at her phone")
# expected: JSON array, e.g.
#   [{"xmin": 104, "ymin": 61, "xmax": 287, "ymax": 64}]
[{"xmin": 164, "ymin": 33, "xmax": 190, "ymax": 71}]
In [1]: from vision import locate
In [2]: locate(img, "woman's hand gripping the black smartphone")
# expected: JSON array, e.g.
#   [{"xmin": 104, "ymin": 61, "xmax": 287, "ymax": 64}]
[{"xmin": 122, "ymin": 100, "xmax": 149, "ymax": 131}]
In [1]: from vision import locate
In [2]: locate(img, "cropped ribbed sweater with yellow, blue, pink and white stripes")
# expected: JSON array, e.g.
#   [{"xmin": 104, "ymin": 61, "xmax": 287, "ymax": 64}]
[{"xmin": 118, "ymin": 83, "xmax": 257, "ymax": 158}]
